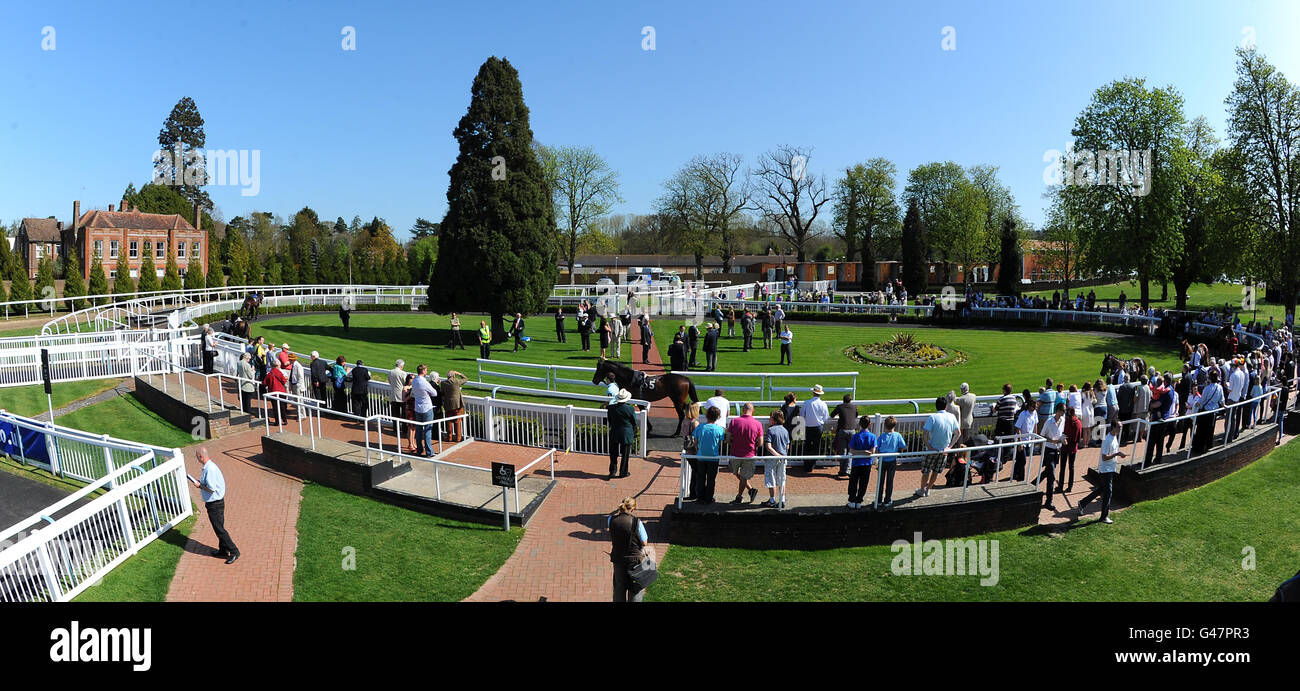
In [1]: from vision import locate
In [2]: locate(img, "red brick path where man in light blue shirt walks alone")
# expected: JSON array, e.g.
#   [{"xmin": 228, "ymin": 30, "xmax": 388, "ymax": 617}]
[{"xmin": 166, "ymin": 427, "xmax": 303, "ymax": 601}]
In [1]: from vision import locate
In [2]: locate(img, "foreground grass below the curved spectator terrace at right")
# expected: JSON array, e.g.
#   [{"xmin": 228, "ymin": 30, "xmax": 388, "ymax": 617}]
[{"xmin": 646, "ymin": 433, "xmax": 1300, "ymax": 601}]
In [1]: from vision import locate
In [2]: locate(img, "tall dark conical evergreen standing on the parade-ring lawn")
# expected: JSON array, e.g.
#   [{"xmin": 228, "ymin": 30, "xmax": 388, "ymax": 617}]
[{"xmin": 429, "ymin": 57, "xmax": 558, "ymax": 339}]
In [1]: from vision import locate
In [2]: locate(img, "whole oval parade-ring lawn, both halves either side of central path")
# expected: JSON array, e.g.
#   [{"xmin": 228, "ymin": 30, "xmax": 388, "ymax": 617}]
[{"xmin": 244, "ymin": 313, "xmax": 1179, "ymax": 410}]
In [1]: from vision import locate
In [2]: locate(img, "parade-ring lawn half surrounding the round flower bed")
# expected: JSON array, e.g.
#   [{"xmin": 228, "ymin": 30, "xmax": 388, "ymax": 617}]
[{"xmin": 655, "ymin": 321, "xmax": 1179, "ymax": 402}]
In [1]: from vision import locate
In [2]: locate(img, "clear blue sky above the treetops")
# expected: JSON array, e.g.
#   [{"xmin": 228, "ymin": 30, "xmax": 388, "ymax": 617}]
[{"xmin": 0, "ymin": 0, "xmax": 1300, "ymax": 238}]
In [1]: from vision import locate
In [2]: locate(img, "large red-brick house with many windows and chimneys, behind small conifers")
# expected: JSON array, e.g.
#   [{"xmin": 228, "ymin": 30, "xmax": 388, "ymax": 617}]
[{"xmin": 73, "ymin": 201, "xmax": 208, "ymax": 281}]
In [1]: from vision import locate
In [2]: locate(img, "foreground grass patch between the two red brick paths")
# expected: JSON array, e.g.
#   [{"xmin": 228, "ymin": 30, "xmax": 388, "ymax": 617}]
[{"xmin": 294, "ymin": 483, "xmax": 523, "ymax": 601}]
